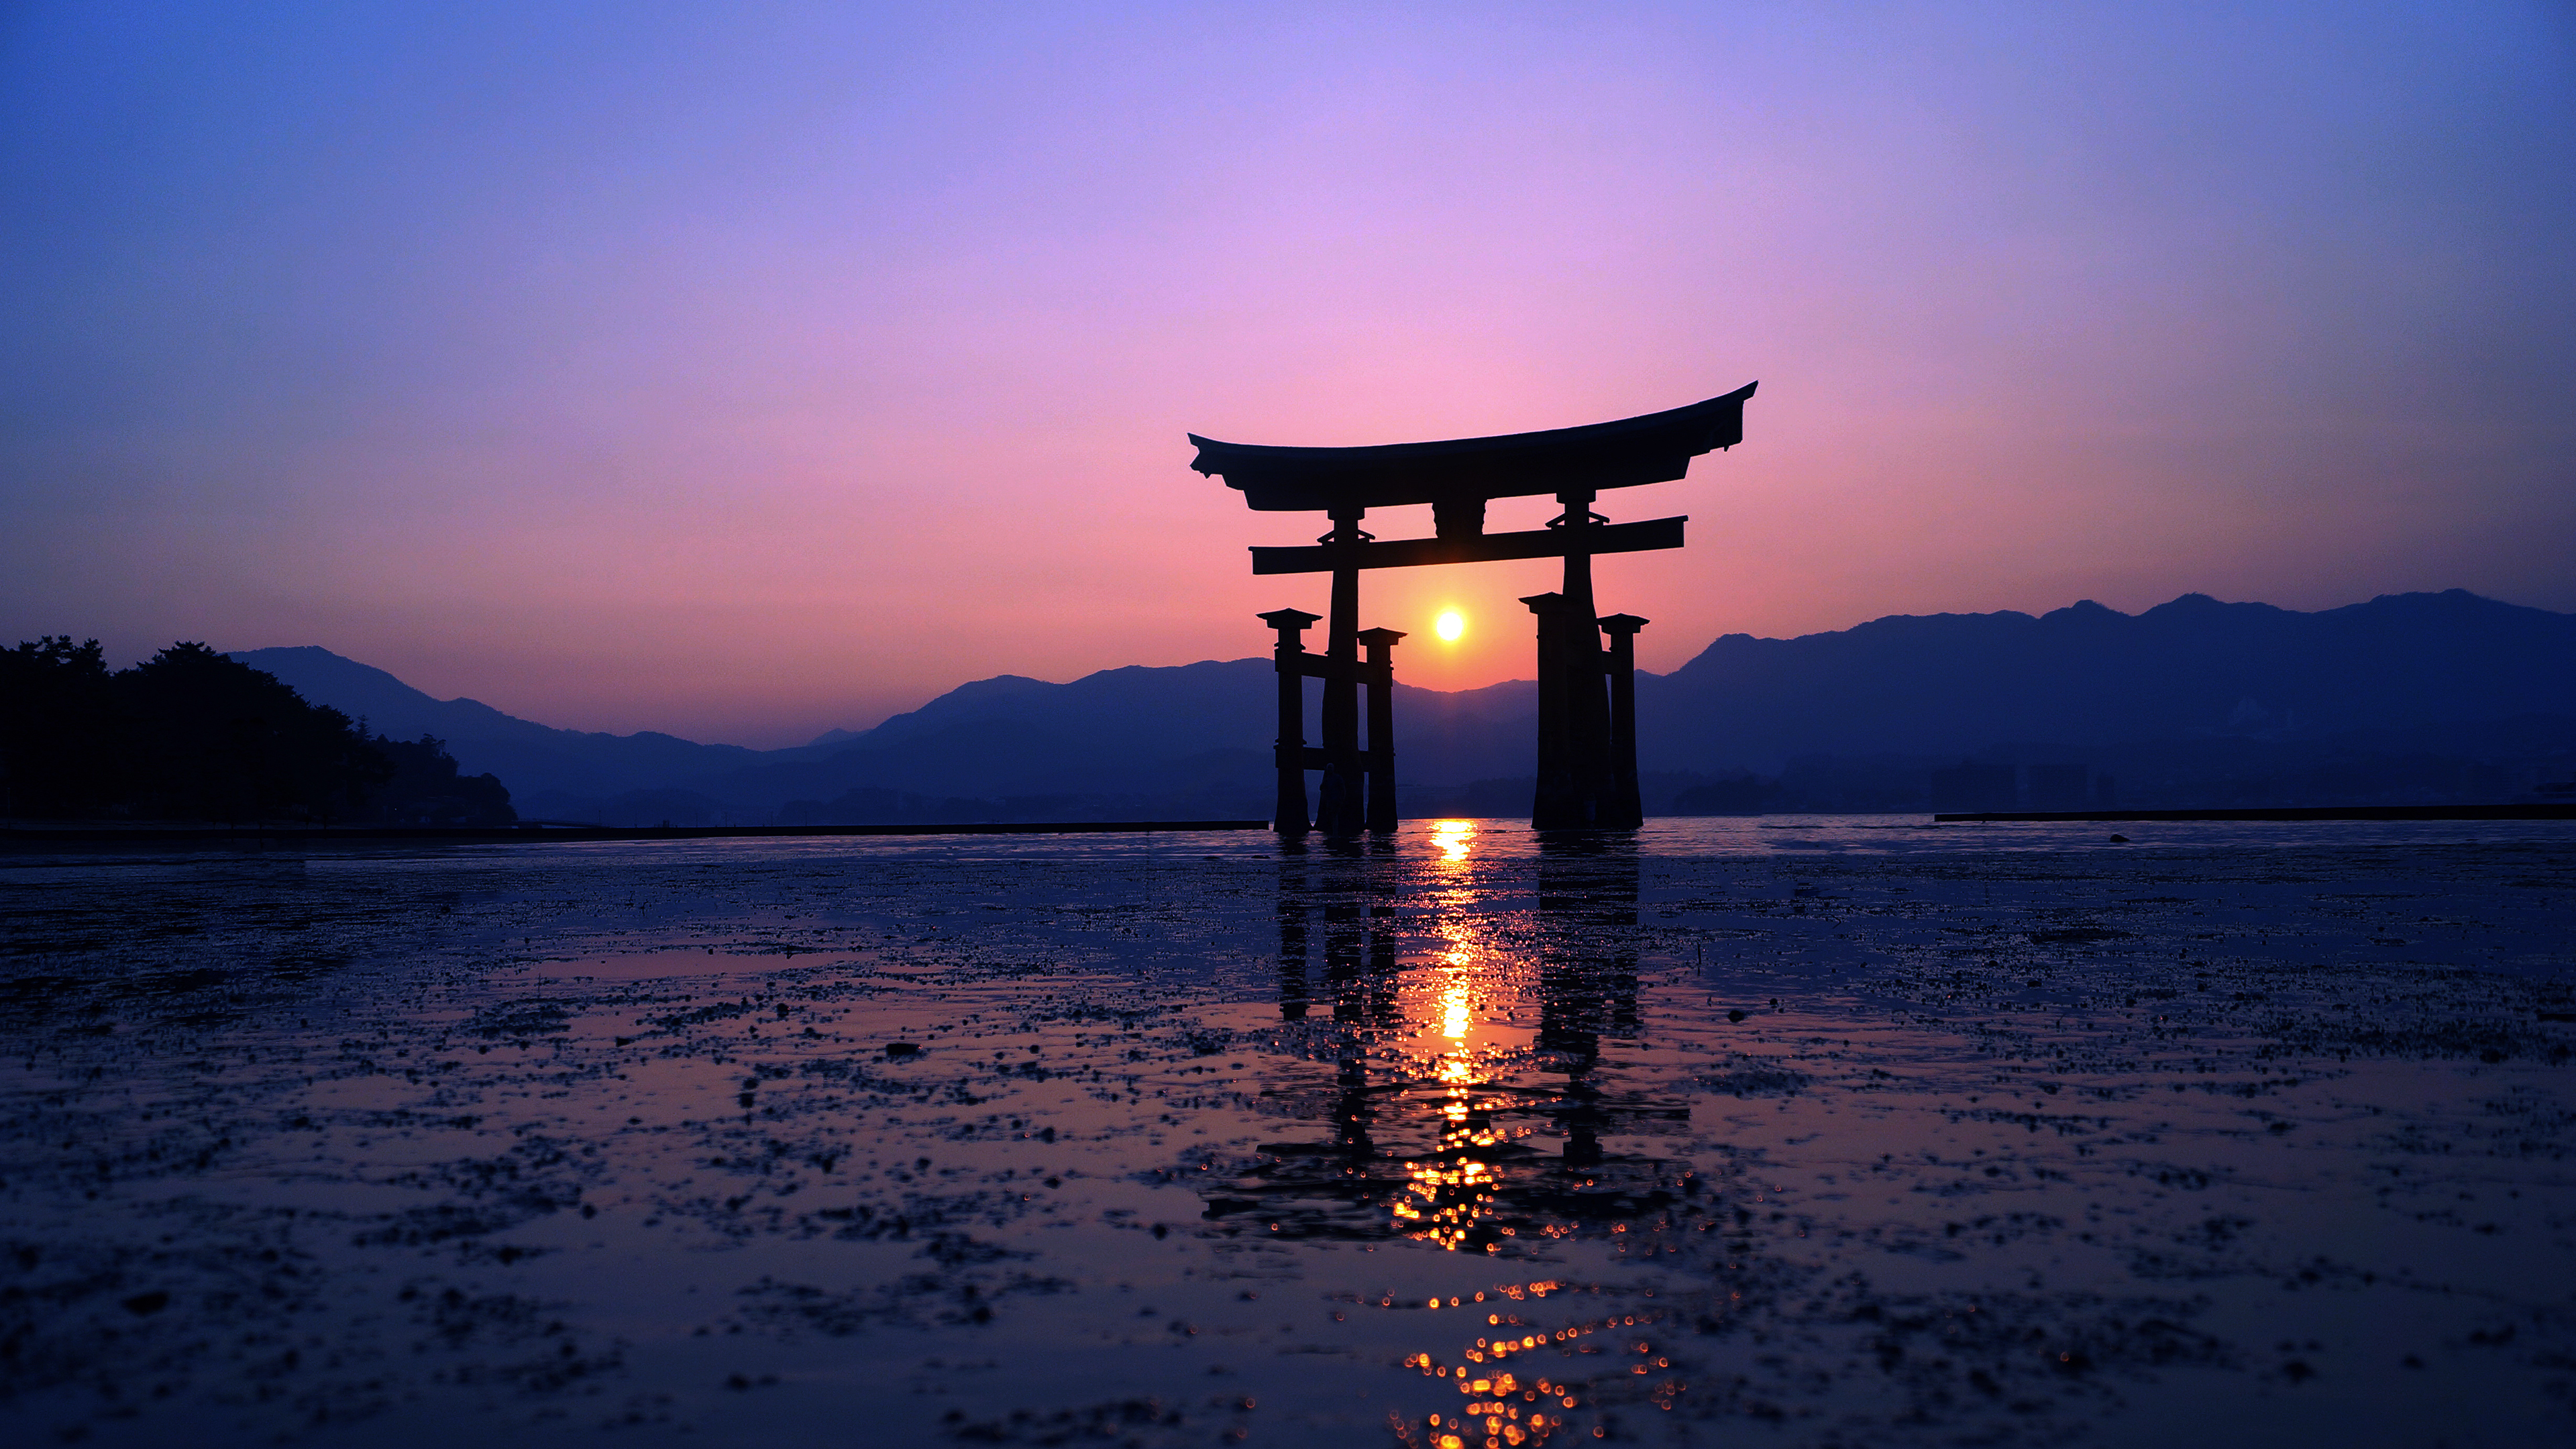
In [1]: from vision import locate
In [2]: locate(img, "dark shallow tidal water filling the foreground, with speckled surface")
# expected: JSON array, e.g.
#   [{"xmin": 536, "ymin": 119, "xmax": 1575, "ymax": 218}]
[{"xmin": 0, "ymin": 817, "xmax": 2576, "ymax": 1449}]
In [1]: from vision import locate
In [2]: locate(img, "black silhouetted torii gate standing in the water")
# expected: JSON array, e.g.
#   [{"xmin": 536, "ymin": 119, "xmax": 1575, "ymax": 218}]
[{"xmin": 1190, "ymin": 384, "xmax": 1754, "ymax": 835}]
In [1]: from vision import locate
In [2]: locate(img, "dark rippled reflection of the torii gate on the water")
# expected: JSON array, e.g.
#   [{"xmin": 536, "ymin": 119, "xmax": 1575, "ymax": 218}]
[{"xmin": 1200, "ymin": 843, "xmax": 1700, "ymax": 1250}]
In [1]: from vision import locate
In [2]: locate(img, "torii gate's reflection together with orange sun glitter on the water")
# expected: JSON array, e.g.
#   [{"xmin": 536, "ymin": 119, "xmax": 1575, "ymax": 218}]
[{"xmin": 1200, "ymin": 820, "xmax": 1713, "ymax": 1423}]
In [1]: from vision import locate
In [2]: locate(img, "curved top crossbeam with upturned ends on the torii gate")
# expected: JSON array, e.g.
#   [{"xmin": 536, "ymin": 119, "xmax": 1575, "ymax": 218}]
[{"xmin": 1190, "ymin": 384, "xmax": 1754, "ymax": 513}]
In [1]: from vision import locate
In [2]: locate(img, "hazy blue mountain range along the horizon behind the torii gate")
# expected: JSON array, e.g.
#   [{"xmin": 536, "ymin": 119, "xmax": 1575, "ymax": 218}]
[{"xmin": 232, "ymin": 590, "xmax": 2576, "ymax": 822}]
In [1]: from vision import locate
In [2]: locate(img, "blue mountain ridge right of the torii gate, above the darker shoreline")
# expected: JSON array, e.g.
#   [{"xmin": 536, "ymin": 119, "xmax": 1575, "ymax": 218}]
[{"xmin": 1638, "ymin": 588, "xmax": 2576, "ymax": 768}]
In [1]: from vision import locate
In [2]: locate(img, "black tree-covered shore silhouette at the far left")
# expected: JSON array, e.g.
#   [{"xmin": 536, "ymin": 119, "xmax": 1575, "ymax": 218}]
[{"xmin": 0, "ymin": 634, "xmax": 518, "ymax": 825}]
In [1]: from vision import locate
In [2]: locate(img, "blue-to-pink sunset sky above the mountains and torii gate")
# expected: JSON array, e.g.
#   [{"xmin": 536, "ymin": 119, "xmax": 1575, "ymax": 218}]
[{"xmin": 0, "ymin": 0, "xmax": 2576, "ymax": 745}]
